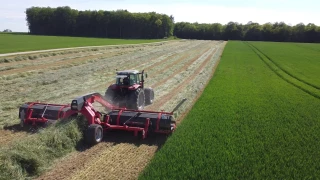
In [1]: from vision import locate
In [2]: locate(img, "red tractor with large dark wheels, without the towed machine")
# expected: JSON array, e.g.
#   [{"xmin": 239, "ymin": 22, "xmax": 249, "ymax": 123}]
[{"xmin": 105, "ymin": 70, "xmax": 154, "ymax": 110}]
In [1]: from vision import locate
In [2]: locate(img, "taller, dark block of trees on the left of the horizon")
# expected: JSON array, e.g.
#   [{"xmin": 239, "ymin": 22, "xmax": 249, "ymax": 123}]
[{"xmin": 26, "ymin": 6, "xmax": 174, "ymax": 39}]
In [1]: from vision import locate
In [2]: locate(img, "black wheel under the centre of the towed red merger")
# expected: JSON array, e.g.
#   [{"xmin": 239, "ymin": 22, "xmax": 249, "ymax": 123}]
[{"xmin": 85, "ymin": 124, "xmax": 103, "ymax": 145}]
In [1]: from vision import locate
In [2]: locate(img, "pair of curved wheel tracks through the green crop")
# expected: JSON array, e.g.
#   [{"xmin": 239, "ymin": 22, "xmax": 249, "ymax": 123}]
[{"xmin": 244, "ymin": 42, "xmax": 320, "ymax": 99}]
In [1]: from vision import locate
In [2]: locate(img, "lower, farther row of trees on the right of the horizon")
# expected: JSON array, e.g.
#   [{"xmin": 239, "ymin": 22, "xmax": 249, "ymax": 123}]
[{"xmin": 174, "ymin": 22, "xmax": 320, "ymax": 43}]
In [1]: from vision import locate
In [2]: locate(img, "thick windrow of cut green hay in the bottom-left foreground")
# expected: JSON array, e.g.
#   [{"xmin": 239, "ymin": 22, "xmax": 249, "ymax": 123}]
[{"xmin": 0, "ymin": 117, "xmax": 85, "ymax": 180}]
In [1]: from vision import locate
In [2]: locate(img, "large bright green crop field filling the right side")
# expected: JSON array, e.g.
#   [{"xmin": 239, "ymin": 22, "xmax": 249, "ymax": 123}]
[{"xmin": 140, "ymin": 41, "xmax": 320, "ymax": 179}]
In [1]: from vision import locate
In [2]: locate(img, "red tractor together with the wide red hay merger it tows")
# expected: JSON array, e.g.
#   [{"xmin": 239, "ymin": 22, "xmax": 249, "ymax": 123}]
[{"xmin": 19, "ymin": 70, "xmax": 186, "ymax": 145}]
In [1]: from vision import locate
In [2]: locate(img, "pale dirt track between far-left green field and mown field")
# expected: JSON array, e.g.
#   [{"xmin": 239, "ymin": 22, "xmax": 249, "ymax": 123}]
[{"xmin": 0, "ymin": 40, "xmax": 182, "ymax": 57}]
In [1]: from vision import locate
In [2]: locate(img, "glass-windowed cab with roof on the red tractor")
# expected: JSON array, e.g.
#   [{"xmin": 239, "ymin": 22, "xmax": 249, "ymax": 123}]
[{"xmin": 116, "ymin": 70, "xmax": 143, "ymax": 86}]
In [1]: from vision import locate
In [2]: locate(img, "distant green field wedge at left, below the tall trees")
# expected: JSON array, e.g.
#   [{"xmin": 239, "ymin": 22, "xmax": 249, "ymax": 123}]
[{"xmin": 0, "ymin": 33, "xmax": 170, "ymax": 54}]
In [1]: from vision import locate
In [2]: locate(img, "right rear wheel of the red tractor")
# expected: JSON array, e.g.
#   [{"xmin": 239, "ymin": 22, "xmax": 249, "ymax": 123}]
[{"xmin": 127, "ymin": 88, "xmax": 145, "ymax": 110}]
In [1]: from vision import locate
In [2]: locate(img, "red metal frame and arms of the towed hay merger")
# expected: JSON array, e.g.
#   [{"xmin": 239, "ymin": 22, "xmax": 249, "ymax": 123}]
[{"xmin": 20, "ymin": 95, "xmax": 176, "ymax": 139}]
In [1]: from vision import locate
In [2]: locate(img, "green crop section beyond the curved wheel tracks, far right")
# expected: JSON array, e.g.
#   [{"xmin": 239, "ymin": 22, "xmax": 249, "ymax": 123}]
[{"xmin": 251, "ymin": 42, "xmax": 320, "ymax": 89}]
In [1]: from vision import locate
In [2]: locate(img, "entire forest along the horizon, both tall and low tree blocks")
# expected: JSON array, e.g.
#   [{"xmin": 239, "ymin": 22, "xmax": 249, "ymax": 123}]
[{"xmin": 26, "ymin": 6, "xmax": 320, "ymax": 42}]
